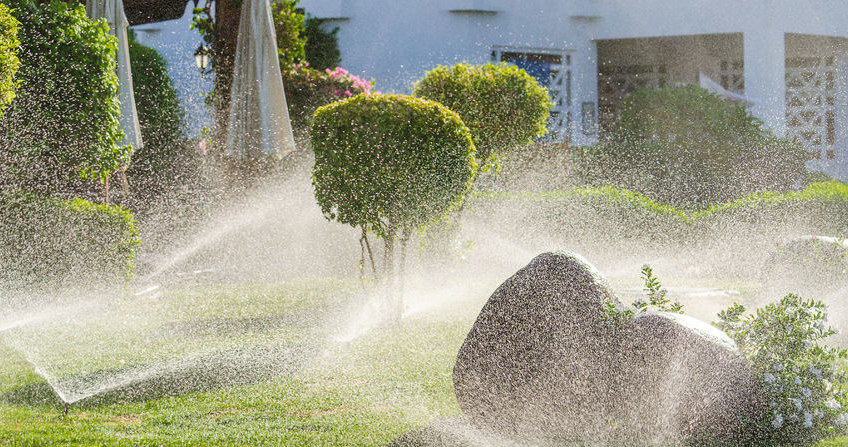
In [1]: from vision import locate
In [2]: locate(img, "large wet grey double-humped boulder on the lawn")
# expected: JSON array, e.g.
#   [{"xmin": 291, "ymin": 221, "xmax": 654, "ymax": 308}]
[{"xmin": 454, "ymin": 252, "xmax": 760, "ymax": 445}]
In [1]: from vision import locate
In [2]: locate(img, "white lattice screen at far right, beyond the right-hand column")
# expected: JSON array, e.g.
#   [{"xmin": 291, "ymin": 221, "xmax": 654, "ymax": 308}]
[{"xmin": 786, "ymin": 56, "xmax": 837, "ymax": 160}]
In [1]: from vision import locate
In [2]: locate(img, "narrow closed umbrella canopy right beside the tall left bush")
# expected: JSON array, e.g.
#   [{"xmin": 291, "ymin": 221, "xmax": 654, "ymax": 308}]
[{"xmin": 85, "ymin": 0, "xmax": 144, "ymax": 150}]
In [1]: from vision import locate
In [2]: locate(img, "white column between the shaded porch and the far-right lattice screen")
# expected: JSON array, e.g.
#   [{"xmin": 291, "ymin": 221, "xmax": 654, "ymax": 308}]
[{"xmin": 743, "ymin": 21, "xmax": 786, "ymax": 136}]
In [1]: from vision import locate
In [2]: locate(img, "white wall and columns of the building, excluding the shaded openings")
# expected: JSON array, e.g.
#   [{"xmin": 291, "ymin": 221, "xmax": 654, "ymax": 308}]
[{"xmin": 300, "ymin": 0, "xmax": 848, "ymax": 179}]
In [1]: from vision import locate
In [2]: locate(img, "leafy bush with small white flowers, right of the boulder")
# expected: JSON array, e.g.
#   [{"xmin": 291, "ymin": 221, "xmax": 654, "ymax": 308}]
[{"xmin": 716, "ymin": 294, "xmax": 848, "ymax": 445}]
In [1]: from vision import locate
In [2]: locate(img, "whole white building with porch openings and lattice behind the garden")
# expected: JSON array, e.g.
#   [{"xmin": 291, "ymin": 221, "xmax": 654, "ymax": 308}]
[{"xmin": 300, "ymin": 0, "xmax": 848, "ymax": 180}]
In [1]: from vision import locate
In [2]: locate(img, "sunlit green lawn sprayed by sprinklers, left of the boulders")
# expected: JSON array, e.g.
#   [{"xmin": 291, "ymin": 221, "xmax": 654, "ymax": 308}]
[{"xmin": 0, "ymin": 279, "xmax": 848, "ymax": 446}]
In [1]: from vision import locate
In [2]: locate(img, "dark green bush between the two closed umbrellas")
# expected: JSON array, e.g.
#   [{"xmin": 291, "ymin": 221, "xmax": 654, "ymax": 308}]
[{"xmin": 127, "ymin": 34, "xmax": 189, "ymax": 205}]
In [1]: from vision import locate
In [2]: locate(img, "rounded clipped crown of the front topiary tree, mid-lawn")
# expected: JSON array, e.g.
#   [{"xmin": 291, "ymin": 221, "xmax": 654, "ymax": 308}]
[{"xmin": 311, "ymin": 95, "xmax": 476, "ymax": 243}]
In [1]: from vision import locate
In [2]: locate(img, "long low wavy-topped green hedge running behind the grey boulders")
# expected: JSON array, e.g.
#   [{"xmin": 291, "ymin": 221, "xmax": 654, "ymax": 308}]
[{"xmin": 470, "ymin": 181, "xmax": 848, "ymax": 245}]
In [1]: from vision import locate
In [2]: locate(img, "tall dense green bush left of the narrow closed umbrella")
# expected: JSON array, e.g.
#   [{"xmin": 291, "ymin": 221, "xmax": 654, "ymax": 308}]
[{"xmin": 0, "ymin": 0, "xmax": 127, "ymax": 192}]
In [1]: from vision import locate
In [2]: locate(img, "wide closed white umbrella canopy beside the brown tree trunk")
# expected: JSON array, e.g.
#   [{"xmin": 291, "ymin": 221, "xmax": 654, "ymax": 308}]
[{"xmin": 226, "ymin": 0, "xmax": 295, "ymax": 157}]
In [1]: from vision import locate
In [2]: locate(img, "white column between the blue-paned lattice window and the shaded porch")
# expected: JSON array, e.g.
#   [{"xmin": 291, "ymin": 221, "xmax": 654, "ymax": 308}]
[{"xmin": 570, "ymin": 36, "xmax": 598, "ymax": 146}]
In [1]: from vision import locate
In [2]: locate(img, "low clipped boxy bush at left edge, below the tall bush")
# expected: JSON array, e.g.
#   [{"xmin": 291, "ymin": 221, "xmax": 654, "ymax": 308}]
[{"xmin": 0, "ymin": 192, "xmax": 139, "ymax": 291}]
